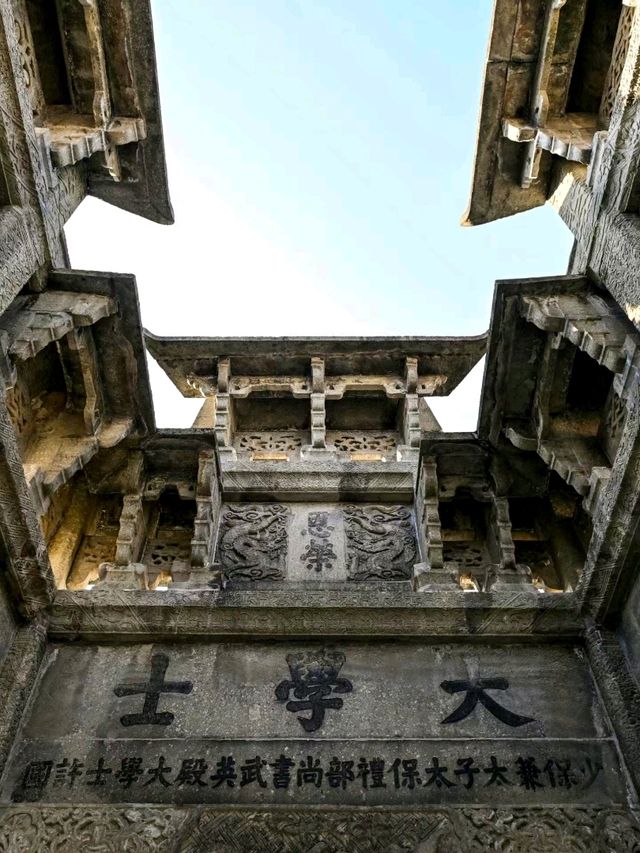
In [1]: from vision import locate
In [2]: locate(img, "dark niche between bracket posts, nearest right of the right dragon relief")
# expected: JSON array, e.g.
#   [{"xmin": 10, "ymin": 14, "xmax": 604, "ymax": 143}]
[{"xmin": 438, "ymin": 488, "xmax": 500, "ymax": 586}]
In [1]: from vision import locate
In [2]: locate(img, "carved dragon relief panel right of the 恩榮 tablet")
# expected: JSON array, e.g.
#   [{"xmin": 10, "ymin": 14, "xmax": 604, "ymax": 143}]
[{"xmin": 344, "ymin": 506, "xmax": 416, "ymax": 581}]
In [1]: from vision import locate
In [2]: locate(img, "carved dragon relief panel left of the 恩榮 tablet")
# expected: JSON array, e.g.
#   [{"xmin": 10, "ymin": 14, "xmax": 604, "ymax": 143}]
[{"xmin": 218, "ymin": 504, "xmax": 289, "ymax": 581}]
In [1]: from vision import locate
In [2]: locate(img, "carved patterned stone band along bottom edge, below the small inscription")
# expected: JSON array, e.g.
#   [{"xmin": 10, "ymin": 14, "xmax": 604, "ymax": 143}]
[{"xmin": 0, "ymin": 806, "xmax": 640, "ymax": 853}]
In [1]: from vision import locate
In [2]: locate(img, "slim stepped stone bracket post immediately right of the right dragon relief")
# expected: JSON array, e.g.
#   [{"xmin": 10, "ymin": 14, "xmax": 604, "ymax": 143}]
[{"xmin": 413, "ymin": 457, "xmax": 457, "ymax": 592}]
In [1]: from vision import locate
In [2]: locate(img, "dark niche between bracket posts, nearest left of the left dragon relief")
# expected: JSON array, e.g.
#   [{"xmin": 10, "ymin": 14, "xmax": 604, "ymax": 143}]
[{"xmin": 142, "ymin": 486, "xmax": 196, "ymax": 589}]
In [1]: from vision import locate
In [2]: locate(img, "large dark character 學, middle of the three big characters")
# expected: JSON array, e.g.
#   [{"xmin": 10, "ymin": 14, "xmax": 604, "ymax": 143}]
[{"xmin": 276, "ymin": 651, "xmax": 353, "ymax": 732}]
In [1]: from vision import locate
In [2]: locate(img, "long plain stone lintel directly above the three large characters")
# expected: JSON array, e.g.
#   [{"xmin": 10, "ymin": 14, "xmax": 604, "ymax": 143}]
[{"xmin": 50, "ymin": 584, "xmax": 583, "ymax": 642}]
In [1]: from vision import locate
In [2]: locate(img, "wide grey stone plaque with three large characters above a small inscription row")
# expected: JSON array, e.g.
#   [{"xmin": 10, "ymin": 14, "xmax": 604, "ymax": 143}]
[{"xmin": 2, "ymin": 643, "xmax": 626, "ymax": 806}]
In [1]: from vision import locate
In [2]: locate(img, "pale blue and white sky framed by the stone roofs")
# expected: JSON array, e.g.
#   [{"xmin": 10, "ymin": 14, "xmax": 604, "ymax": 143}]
[{"xmin": 67, "ymin": 0, "xmax": 571, "ymax": 425}]
